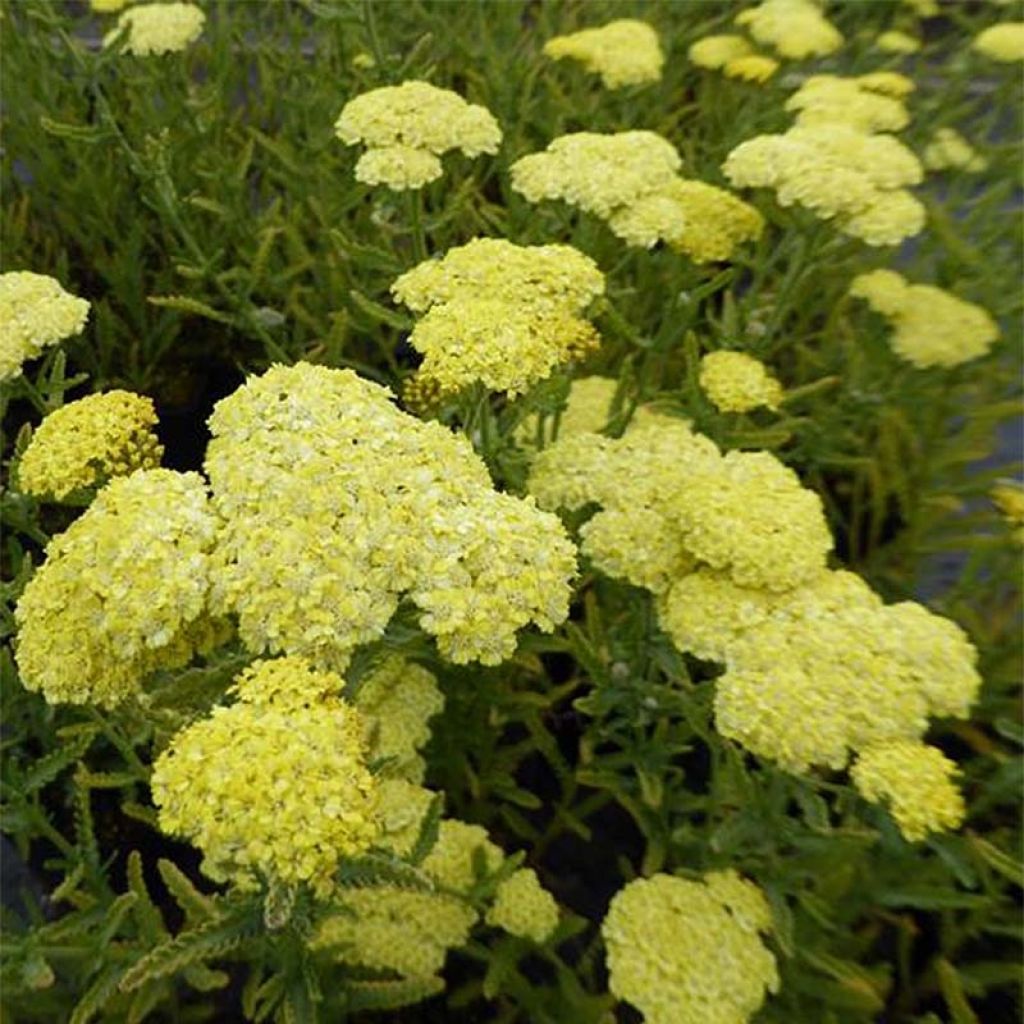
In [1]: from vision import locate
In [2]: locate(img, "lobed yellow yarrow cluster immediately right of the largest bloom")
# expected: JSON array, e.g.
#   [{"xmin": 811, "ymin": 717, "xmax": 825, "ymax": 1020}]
[{"xmin": 528, "ymin": 414, "xmax": 831, "ymax": 594}]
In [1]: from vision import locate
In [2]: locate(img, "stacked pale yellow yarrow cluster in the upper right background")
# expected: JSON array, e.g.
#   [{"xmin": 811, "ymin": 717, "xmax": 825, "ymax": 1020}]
[{"xmin": 723, "ymin": 72, "xmax": 925, "ymax": 246}]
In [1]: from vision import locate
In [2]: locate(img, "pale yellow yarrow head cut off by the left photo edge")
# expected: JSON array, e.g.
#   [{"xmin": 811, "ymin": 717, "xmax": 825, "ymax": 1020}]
[{"xmin": 0, "ymin": 270, "xmax": 89, "ymax": 382}]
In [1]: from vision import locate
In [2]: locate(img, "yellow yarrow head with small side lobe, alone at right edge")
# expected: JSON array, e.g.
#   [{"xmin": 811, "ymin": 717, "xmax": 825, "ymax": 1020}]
[{"xmin": 850, "ymin": 270, "xmax": 999, "ymax": 370}]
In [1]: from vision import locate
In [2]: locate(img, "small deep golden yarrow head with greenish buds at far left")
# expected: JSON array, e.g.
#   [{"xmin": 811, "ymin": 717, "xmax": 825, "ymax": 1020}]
[{"xmin": 17, "ymin": 391, "xmax": 164, "ymax": 501}]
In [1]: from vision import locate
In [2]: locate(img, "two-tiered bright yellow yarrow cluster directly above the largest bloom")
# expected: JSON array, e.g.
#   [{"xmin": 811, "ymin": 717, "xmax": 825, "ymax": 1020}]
[{"xmin": 391, "ymin": 239, "xmax": 604, "ymax": 395}]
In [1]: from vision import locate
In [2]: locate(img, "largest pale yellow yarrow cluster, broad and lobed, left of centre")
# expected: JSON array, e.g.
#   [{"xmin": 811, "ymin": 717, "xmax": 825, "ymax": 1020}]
[{"xmin": 206, "ymin": 364, "xmax": 574, "ymax": 671}]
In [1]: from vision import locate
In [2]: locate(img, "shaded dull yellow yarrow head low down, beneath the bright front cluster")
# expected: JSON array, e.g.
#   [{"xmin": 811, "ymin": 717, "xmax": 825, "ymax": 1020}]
[{"xmin": 309, "ymin": 886, "xmax": 476, "ymax": 974}]
